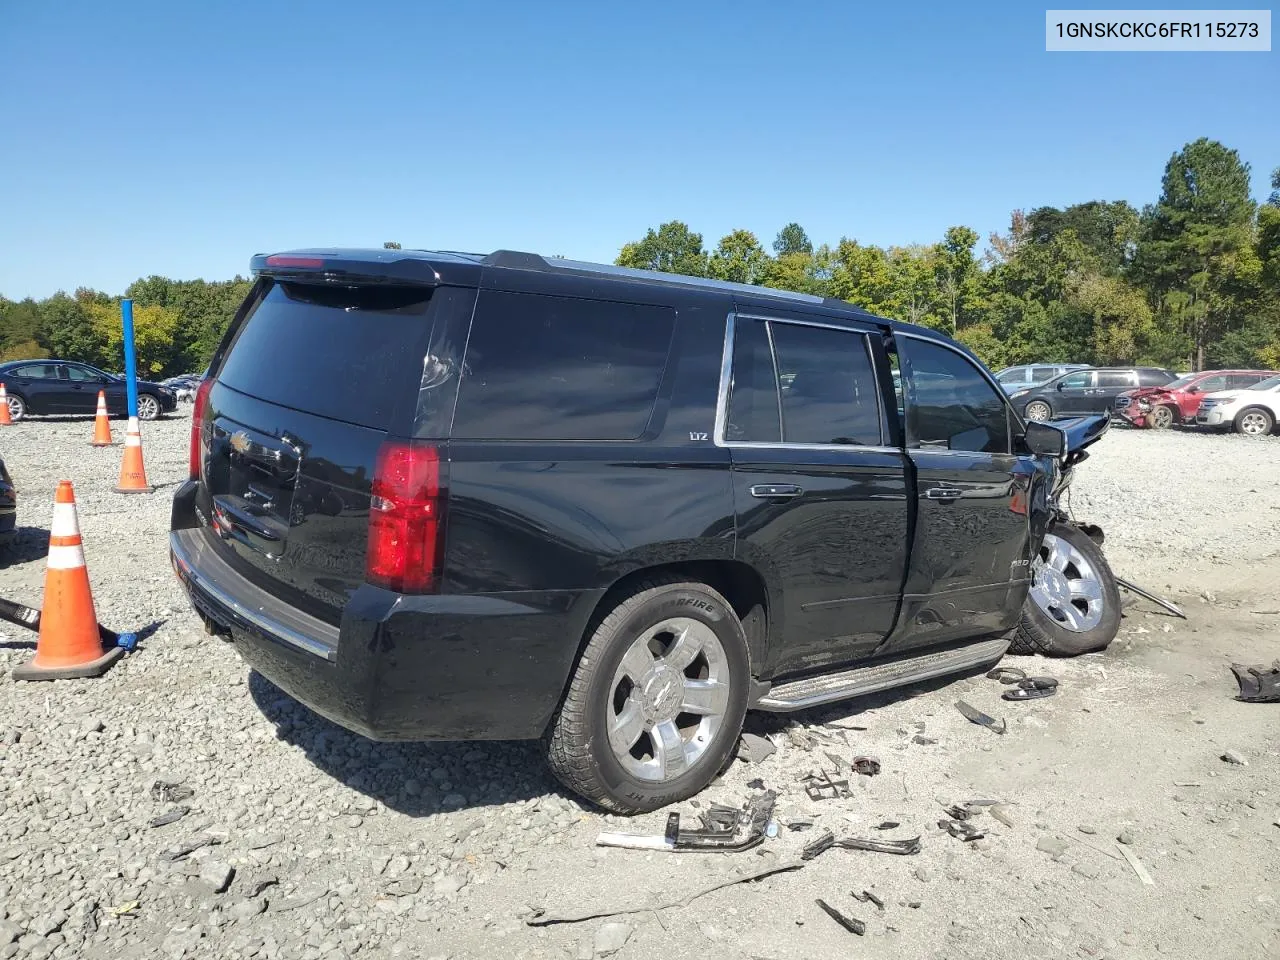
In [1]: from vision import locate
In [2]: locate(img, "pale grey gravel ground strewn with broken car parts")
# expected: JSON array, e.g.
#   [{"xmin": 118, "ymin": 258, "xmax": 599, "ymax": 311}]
[{"xmin": 0, "ymin": 416, "xmax": 1280, "ymax": 960}]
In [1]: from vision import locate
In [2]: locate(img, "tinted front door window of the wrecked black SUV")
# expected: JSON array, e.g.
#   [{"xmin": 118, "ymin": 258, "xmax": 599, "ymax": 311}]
[{"xmin": 897, "ymin": 337, "xmax": 1010, "ymax": 453}]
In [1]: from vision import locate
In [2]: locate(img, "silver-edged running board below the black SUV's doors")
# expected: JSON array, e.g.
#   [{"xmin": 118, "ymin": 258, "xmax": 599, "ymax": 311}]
[{"xmin": 751, "ymin": 639, "xmax": 1009, "ymax": 713}]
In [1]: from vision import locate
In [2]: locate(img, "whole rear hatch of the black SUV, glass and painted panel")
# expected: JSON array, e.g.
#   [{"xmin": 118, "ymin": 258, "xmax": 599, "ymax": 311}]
[{"xmin": 201, "ymin": 279, "xmax": 431, "ymax": 623}]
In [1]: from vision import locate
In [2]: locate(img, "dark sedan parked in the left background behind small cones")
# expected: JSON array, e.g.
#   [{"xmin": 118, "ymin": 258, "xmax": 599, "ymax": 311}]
[{"xmin": 0, "ymin": 360, "xmax": 178, "ymax": 421}]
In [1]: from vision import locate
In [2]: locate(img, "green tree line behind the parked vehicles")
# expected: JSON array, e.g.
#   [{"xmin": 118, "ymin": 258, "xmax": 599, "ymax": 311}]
[{"xmin": 0, "ymin": 138, "xmax": 1280, "ymax": 376}]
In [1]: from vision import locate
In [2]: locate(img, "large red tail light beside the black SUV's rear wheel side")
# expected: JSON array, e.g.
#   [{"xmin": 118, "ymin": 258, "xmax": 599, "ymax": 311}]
[{"xmin": 365, "ymin": 440, "xmax": 445, "ymax": 594}]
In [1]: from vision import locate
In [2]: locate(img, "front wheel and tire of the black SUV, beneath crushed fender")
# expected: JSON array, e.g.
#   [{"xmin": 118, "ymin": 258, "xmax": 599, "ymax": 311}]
[{"xmin": 1009, "ymin": 524, "xmax": 1120, "ymax": 657}]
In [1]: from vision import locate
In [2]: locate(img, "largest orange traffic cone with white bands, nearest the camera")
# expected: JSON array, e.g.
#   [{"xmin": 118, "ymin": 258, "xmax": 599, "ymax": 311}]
[{"xmin": 13, "ymin": 480, "xmax": 124, "ymax": 680}]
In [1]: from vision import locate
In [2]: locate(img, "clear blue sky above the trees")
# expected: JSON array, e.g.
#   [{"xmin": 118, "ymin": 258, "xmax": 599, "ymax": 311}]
[{"xmin": 0, "ymin": 0, "xmax": 1280, "ymax": 298}]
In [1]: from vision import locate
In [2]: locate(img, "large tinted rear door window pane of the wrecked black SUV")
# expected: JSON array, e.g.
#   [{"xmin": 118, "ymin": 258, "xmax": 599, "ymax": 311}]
[{"xmin": 771, "ymin": 323, "xmax": 882, "ymax": 445}]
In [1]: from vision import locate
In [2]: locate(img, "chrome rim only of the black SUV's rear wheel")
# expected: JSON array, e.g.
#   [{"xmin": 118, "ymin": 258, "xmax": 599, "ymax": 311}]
[{"xmin": 605, "ymin": 617, "xmax": 730, "ymax": 781}]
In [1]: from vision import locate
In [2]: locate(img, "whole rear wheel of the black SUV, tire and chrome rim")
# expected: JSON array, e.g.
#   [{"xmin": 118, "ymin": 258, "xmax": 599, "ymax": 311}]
[{"xmin": 545, "ymin": 577, "xmax": 750, "ymax": 814}]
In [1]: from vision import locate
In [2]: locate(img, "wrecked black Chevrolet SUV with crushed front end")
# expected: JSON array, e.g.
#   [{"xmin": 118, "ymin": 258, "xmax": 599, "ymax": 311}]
[{"xmin": 170, "ymin": 250, "xmax": 1119, "ymax": 812}]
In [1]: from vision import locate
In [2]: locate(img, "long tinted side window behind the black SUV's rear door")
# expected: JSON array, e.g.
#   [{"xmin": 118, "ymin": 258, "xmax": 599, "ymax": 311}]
[{"xmin": 453, "ymin": 292, "xmax": 676, "ymax": 440}]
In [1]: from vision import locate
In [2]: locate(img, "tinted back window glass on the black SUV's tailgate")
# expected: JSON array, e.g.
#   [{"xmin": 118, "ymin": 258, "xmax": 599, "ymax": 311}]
[{"xmin": 218, "ymin": 283, "xmax": 431, "ymax": 430}]
